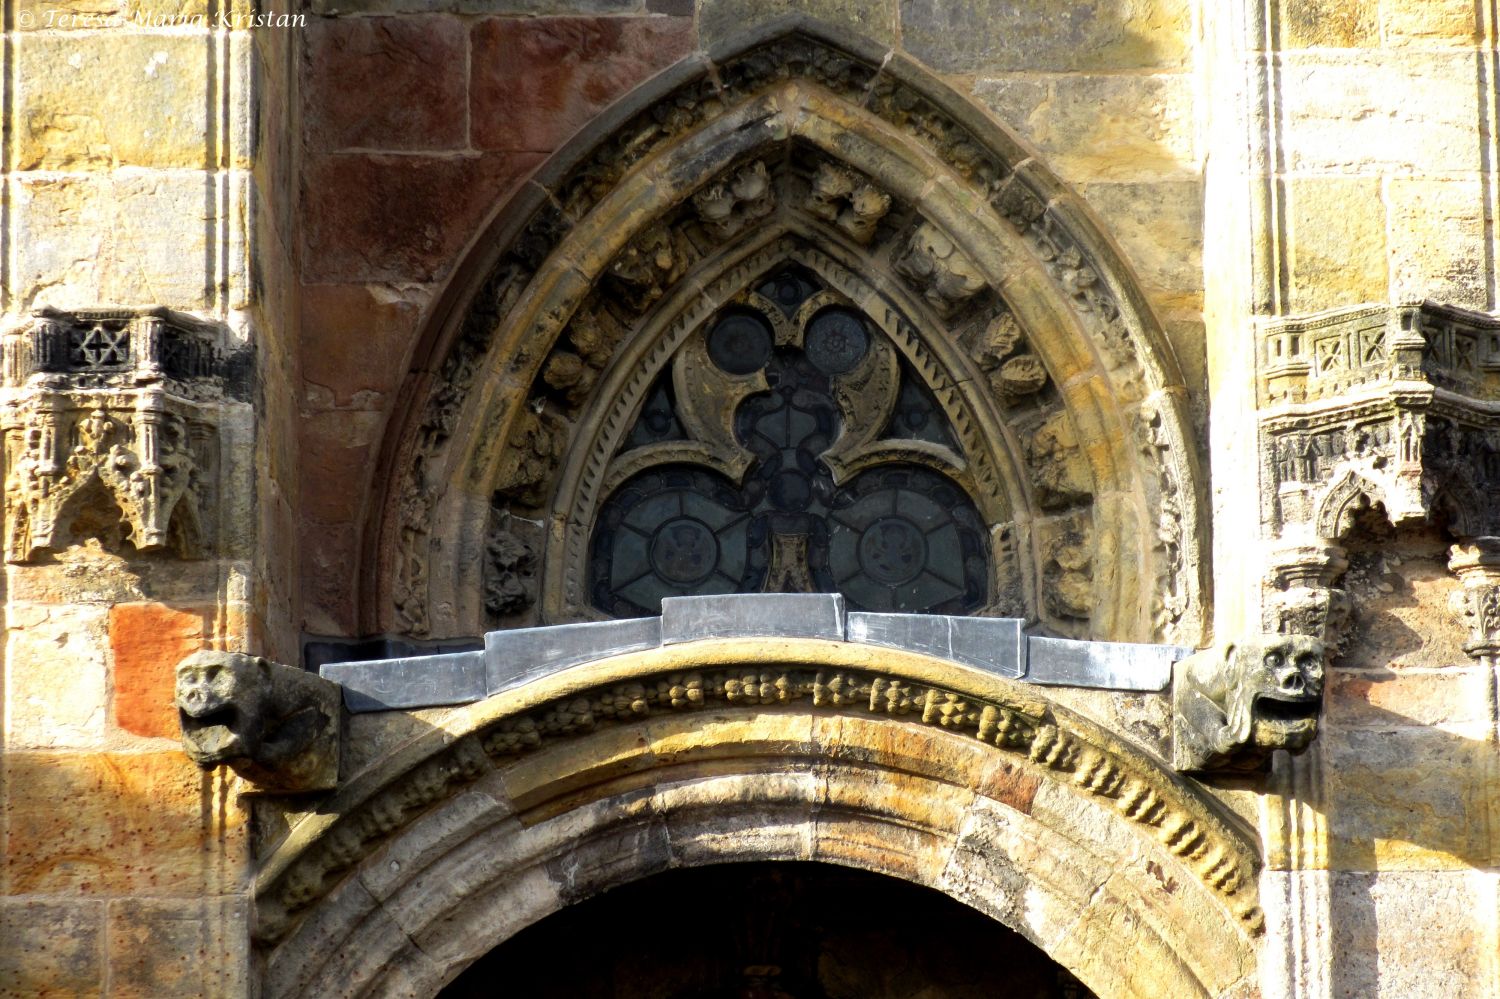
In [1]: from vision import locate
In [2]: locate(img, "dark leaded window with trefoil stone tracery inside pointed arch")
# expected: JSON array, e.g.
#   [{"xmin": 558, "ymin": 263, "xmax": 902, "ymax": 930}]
[{"xmin": 588, "ymin": 269, "xmax": 996, "ymax": 617}]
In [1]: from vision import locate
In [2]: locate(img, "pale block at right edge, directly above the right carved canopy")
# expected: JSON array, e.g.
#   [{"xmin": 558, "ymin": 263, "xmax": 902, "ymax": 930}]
[{"xmin": 1386, "ymin": 177, "xmax": 1494, "ymax": 309}]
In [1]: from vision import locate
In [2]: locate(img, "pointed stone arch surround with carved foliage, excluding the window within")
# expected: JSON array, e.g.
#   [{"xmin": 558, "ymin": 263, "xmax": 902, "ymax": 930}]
[{"xmin": 369, "ymin": 26, "xmax": 1203, "ymax": 644}]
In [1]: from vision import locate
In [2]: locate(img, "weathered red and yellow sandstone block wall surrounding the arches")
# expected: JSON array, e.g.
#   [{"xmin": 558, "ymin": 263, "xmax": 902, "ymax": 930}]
[{"xmin": 0, "ymin": 0, "xmax": 1500, "ymax": 996}]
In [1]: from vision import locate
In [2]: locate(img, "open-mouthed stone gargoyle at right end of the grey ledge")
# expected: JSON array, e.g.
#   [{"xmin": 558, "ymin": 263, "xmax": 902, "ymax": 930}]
[{"xmin": 1172, "ymin": 635, "xmax": 1323, "ymax": 771}]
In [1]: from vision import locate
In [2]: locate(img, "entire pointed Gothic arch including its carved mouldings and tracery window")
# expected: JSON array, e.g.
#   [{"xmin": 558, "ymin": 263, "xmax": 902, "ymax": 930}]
[{"xmin": 365, "ymin": 21, "xmax": 1205, "ymax": 644}]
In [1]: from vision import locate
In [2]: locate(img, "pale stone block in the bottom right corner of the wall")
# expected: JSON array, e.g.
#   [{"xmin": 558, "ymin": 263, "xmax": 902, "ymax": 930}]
[{"xmin": 1328, "ymin": 872, "xmax": 1496, "ymax": 999}]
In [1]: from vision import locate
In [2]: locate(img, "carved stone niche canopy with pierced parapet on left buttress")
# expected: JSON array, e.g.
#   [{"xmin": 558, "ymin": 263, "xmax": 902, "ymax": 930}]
[{"xmin": 0, "ymin": 309, "xmax": 227, "ymax": 563}]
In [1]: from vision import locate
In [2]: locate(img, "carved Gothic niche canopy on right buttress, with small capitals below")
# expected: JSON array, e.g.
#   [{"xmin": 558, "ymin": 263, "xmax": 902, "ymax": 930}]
[{"xmin": 1259, "ymin": 302, "xmax": 1500, "ymax": 645}]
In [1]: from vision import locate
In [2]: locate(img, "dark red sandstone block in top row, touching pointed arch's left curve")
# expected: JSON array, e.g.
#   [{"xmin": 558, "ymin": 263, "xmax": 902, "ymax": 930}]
[{"xmin": 470, "ymin": 18, "xmax": 696, "ymax": 153}]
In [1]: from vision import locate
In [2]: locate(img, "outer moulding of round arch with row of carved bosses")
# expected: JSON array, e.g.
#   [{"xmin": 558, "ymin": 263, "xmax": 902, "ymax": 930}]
[{"xmin": 257, "ymin": 639, "xmax": 1262, "ymax": 996}]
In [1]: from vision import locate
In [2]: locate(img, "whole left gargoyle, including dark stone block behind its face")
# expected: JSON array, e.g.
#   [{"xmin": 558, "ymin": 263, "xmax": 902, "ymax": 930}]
[{"xmin": 177, "ymin": 651, "xmax": 341, "ymax": 794}]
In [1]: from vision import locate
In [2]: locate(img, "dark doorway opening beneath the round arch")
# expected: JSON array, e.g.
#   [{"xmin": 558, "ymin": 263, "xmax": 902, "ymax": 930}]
[{"xmin": 443, "ymin": 863, "xmax": 1092, "ymax": 999}]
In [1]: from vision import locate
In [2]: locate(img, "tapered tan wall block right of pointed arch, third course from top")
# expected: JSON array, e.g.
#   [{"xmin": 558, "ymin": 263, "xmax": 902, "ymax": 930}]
[{"xmin": 1080, "ymin": 180, "xmax": 1205, "ymax": 315}]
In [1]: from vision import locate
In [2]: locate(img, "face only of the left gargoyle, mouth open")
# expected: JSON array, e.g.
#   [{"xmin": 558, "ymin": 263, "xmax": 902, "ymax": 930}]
[{"xmin": 177, "ymin": 650, "xmax": 270, "ymax": 768}]
